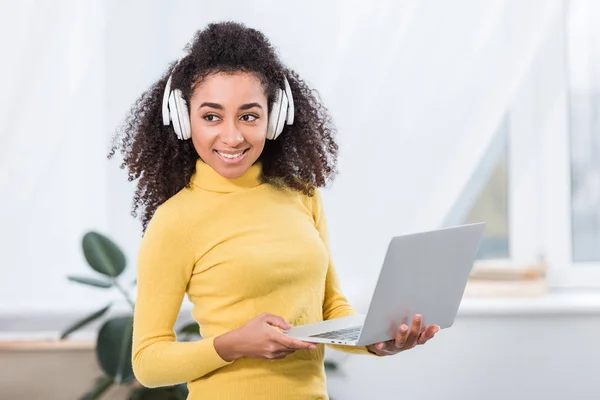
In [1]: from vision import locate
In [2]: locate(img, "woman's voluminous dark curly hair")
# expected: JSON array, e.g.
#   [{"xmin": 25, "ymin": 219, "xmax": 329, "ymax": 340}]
[{"xmin": 108, "ymin": 22, "xmax": 338, "ymax": 230}]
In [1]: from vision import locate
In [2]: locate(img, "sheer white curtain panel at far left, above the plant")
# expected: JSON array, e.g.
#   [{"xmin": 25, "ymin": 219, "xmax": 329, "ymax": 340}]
[{"xmin": 0, "ymin": 0, "xmax": 107, "ymax": 312}]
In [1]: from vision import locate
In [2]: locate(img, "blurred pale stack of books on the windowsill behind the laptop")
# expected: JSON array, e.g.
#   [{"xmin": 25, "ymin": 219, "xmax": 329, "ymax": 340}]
[{"xmin": 465, "ymin": 260, "xmax": 548, "ymax": 297}]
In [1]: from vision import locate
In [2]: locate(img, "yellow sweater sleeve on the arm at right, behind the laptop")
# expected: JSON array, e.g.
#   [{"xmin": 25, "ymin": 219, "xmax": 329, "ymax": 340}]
[{"xmin": 313, "ymin": 190, "xmax": 374, "ymax": 355}]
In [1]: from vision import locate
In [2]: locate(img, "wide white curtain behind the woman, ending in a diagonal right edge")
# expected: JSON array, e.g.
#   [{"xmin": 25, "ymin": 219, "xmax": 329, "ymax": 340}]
[{"xmin": 0, "ymin": 0, "xmax": 561, "ymax": 311}]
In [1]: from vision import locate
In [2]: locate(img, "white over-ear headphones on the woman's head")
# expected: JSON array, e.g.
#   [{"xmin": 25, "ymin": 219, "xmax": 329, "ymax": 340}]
[{"xmin": 162, "ymin": 60, "xmax": 294, "ymax": 140}]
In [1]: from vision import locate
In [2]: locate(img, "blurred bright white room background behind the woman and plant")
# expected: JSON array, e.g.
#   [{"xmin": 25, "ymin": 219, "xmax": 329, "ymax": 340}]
[{"xmin": 0, "ymin": 0, "xmax": 600, "ymax": 400}]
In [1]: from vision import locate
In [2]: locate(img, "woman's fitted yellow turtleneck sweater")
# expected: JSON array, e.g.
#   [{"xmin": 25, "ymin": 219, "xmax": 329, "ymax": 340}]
[{"xmin": 133, "ymin": 160, "xmax": 370, "ymax": 400}]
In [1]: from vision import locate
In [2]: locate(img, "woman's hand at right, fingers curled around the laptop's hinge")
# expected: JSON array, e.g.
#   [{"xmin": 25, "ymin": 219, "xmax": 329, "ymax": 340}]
[{"xmin": 367, "ymin": 314, "xmax": 440, "ymax": 356}]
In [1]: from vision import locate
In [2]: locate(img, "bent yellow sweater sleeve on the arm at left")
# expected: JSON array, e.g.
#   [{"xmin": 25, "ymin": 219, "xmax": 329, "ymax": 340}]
[{"xmin": 132, "ymin": 205, "xmax": 229, "ymax": 387}]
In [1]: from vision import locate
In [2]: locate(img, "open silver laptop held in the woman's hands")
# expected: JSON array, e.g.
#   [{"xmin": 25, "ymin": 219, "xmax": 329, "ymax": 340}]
[{"xmin": 284, "ymin": 223, "xmax": 485, "ymax": 346}]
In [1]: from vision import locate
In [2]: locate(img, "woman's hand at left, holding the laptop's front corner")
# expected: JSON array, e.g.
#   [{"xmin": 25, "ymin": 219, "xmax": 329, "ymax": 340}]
[{"xmin": 214, "ymin": 313, "xmax": 316, "ymax": 361}]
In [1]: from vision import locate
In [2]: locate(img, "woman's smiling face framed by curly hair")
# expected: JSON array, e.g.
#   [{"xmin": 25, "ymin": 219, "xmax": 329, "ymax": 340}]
[{"xmin": 190, "ymin": 72, "xmax": 268, "ymax": 179}]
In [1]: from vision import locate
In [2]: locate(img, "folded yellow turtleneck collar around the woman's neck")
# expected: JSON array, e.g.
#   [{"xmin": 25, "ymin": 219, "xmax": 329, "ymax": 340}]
[{"xmin": 192, "ymin": 159, "xmax": 262, "ymax": 193}]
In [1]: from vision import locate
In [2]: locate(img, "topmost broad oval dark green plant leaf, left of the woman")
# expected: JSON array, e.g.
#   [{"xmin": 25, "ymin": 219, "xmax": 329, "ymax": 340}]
[{"xmin": 82, "ymin": 232, "xmax": 126, "ymax": 278}]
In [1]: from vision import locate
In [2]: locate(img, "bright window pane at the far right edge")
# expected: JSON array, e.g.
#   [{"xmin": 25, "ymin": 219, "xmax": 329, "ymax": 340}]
[{"xmin": 566, "ymin": 0, "xmax": 600, "ymax": 263}]
